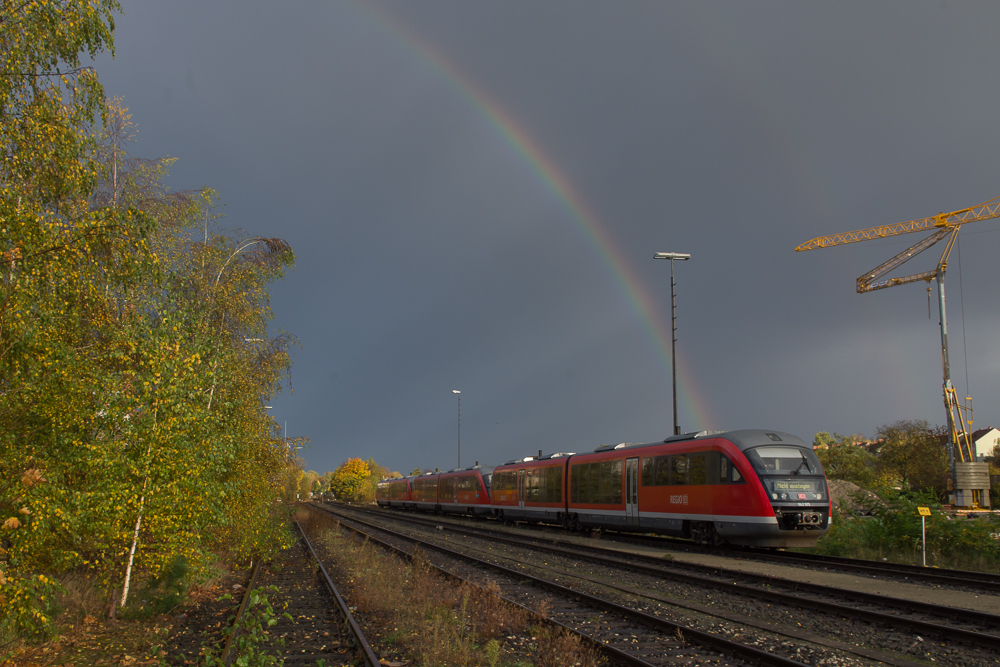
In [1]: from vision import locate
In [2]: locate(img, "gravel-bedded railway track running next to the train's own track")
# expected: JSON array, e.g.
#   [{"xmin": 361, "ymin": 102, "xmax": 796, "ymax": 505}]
[{"xmin": 318, "ymin": 508, "xmax": 1000, "ymax": 665}]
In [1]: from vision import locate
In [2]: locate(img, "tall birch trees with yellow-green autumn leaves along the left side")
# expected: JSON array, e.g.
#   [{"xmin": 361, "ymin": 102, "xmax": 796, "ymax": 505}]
[{"xmin": 0, "ymin": 5, "xmax": 294, "ymax": 636}]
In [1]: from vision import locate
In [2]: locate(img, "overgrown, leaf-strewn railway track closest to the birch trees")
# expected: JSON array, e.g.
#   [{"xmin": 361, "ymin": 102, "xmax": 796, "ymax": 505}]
[{"xmin": 213, "ymin": 521, "xmax": 379, "ymax": 667}]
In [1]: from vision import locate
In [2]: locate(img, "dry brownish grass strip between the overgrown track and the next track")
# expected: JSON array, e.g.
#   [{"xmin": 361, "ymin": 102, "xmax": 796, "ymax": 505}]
[{"xmin": 303, "ymin": 511, "xmax": 597, "ymax": 667}]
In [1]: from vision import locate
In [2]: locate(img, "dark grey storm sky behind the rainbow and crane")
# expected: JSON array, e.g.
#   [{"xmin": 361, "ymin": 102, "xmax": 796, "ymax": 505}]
[{"xmin": 97, "ymin": 0, "xmax": 1000, "ymax": 472}]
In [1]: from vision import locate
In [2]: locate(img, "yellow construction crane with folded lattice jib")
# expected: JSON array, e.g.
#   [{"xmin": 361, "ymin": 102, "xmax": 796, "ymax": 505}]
[{"xmin": 795, "ymin": 197, "xmax": 1000, "ymax": 507}]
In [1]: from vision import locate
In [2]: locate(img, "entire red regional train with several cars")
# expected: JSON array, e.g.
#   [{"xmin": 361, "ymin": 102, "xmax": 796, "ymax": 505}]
[{"xmin": 376, "ymin": 430, "xmax": 831, "ymax": 547}]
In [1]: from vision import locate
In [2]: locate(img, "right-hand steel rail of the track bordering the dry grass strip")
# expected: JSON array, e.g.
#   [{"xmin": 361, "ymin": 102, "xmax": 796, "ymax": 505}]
[{"xmin": 314, "ymin": 508, "xmax": 804, "ymax": 667}]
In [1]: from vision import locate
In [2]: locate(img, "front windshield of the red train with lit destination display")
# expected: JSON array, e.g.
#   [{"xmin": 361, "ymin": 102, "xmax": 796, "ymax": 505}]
[{"xmin": 744, "ymin": 445, "xmax": 827, "ymax": 502}]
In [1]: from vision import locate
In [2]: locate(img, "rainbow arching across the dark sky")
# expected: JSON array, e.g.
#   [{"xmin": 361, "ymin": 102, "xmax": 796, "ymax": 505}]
[{"xmin": 359, "ymin": 3, "xmax": 714, "ymax": 431}]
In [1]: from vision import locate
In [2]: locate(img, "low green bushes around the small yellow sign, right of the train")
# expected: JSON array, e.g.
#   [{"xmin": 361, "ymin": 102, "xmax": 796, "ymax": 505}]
[{"xmin": 816, "ymin": 487, "xmax": 1000, "ymax": 571}]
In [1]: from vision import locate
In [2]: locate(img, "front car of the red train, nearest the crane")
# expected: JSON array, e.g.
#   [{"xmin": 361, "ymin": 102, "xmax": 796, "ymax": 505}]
[{"xmin": 564, "ymin": 430, "xmax": 830, "ymax": 547}]
